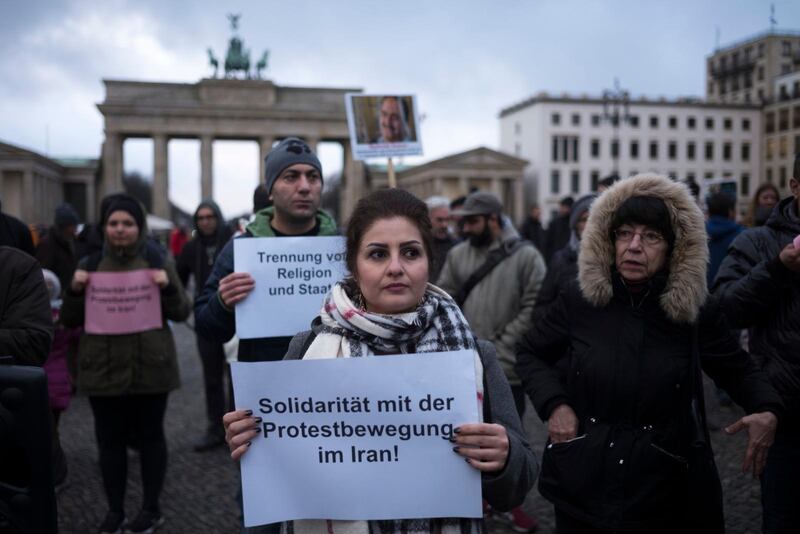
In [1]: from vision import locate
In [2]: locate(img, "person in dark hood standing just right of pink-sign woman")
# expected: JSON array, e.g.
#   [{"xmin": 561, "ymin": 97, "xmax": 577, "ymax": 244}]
[{"xmin": 177, "ymin": 200, "xmax": 232, "ymax": 452}]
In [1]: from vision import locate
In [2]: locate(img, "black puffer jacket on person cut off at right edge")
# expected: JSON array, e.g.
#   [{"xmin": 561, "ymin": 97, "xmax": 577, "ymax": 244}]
[{"xmin": 714, "ymin": 197, "xmax": 800, "ymax": 433}]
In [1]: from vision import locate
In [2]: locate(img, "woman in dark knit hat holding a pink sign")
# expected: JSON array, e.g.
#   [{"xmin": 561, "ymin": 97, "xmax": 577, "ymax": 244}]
[{"xmin": 61, "ymin": 195, "xmax": 189, "ymax": 533}]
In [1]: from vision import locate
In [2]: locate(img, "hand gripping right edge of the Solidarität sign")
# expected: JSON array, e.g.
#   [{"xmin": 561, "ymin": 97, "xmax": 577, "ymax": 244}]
[{"xmin": 450, "ymin": 423, "xmax": 508, "ymax": 473}]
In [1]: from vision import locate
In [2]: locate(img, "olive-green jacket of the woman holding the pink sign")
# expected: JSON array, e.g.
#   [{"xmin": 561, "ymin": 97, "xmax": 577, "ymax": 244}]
[{"xmin": 61, "ymin": 241, "xmax": 190, "ymax": 396}]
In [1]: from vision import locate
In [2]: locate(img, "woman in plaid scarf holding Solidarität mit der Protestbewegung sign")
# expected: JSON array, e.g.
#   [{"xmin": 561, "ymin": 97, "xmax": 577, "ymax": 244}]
[{"xmin": 223, "ymin": 189, "xmax": 538, "ymax": 534}]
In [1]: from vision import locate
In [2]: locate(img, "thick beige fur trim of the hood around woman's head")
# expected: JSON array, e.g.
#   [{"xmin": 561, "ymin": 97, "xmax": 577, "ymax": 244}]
[{"xmin": 578, "ymin": 174, "xmax": 708, "ymax": 323}]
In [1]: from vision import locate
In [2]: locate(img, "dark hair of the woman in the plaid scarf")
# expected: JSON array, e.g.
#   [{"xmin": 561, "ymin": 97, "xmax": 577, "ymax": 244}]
[{"xmin": 345, "ymin": 189, "xmax": 433, "ymax": 275}]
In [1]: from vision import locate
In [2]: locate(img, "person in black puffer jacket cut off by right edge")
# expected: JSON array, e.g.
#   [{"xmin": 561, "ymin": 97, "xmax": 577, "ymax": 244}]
[{"xmin": 714, "ymin": 156, "xmax": 800, "ymax": 533}]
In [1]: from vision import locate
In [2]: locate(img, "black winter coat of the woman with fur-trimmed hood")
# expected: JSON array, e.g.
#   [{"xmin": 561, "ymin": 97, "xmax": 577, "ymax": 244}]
[{"xmin": 517, "ymin": 274, "xmax": 781, "ymax": 531}]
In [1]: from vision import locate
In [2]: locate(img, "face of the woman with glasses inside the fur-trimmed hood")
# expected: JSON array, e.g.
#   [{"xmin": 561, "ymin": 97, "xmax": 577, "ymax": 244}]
[{"xmin": 614, "ymin": 224, "xmax": 669, "ymax": 283}]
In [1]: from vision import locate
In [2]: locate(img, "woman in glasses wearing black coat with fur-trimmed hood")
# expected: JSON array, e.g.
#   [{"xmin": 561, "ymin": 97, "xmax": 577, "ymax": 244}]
[{"xmin": 517, "ymin": 174, "xmax": 783, "ymax": 533}]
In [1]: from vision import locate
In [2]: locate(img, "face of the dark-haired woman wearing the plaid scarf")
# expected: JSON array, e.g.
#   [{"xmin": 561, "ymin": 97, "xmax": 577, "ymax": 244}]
[{"xmin": 354, "ymin": 217, "xmax": 428, "ymax": 314}]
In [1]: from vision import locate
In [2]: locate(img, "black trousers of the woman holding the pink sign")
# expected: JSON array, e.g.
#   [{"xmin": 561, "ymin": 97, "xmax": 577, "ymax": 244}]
[{"xmin": 89, "ymin": 393, "xmax": 168, "ymax": 513}]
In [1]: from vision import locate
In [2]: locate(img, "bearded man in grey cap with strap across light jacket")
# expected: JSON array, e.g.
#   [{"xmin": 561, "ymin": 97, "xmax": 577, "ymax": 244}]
[{"xmin": 437, "ymin": 191, "xmax": 546, "ymax": 532}]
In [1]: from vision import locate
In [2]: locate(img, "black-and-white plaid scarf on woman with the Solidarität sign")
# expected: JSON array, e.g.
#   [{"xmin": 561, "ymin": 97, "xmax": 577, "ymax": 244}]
[{"xmin": 292, "ymin": 282, "xmax": 485, "ymax": 534}]
